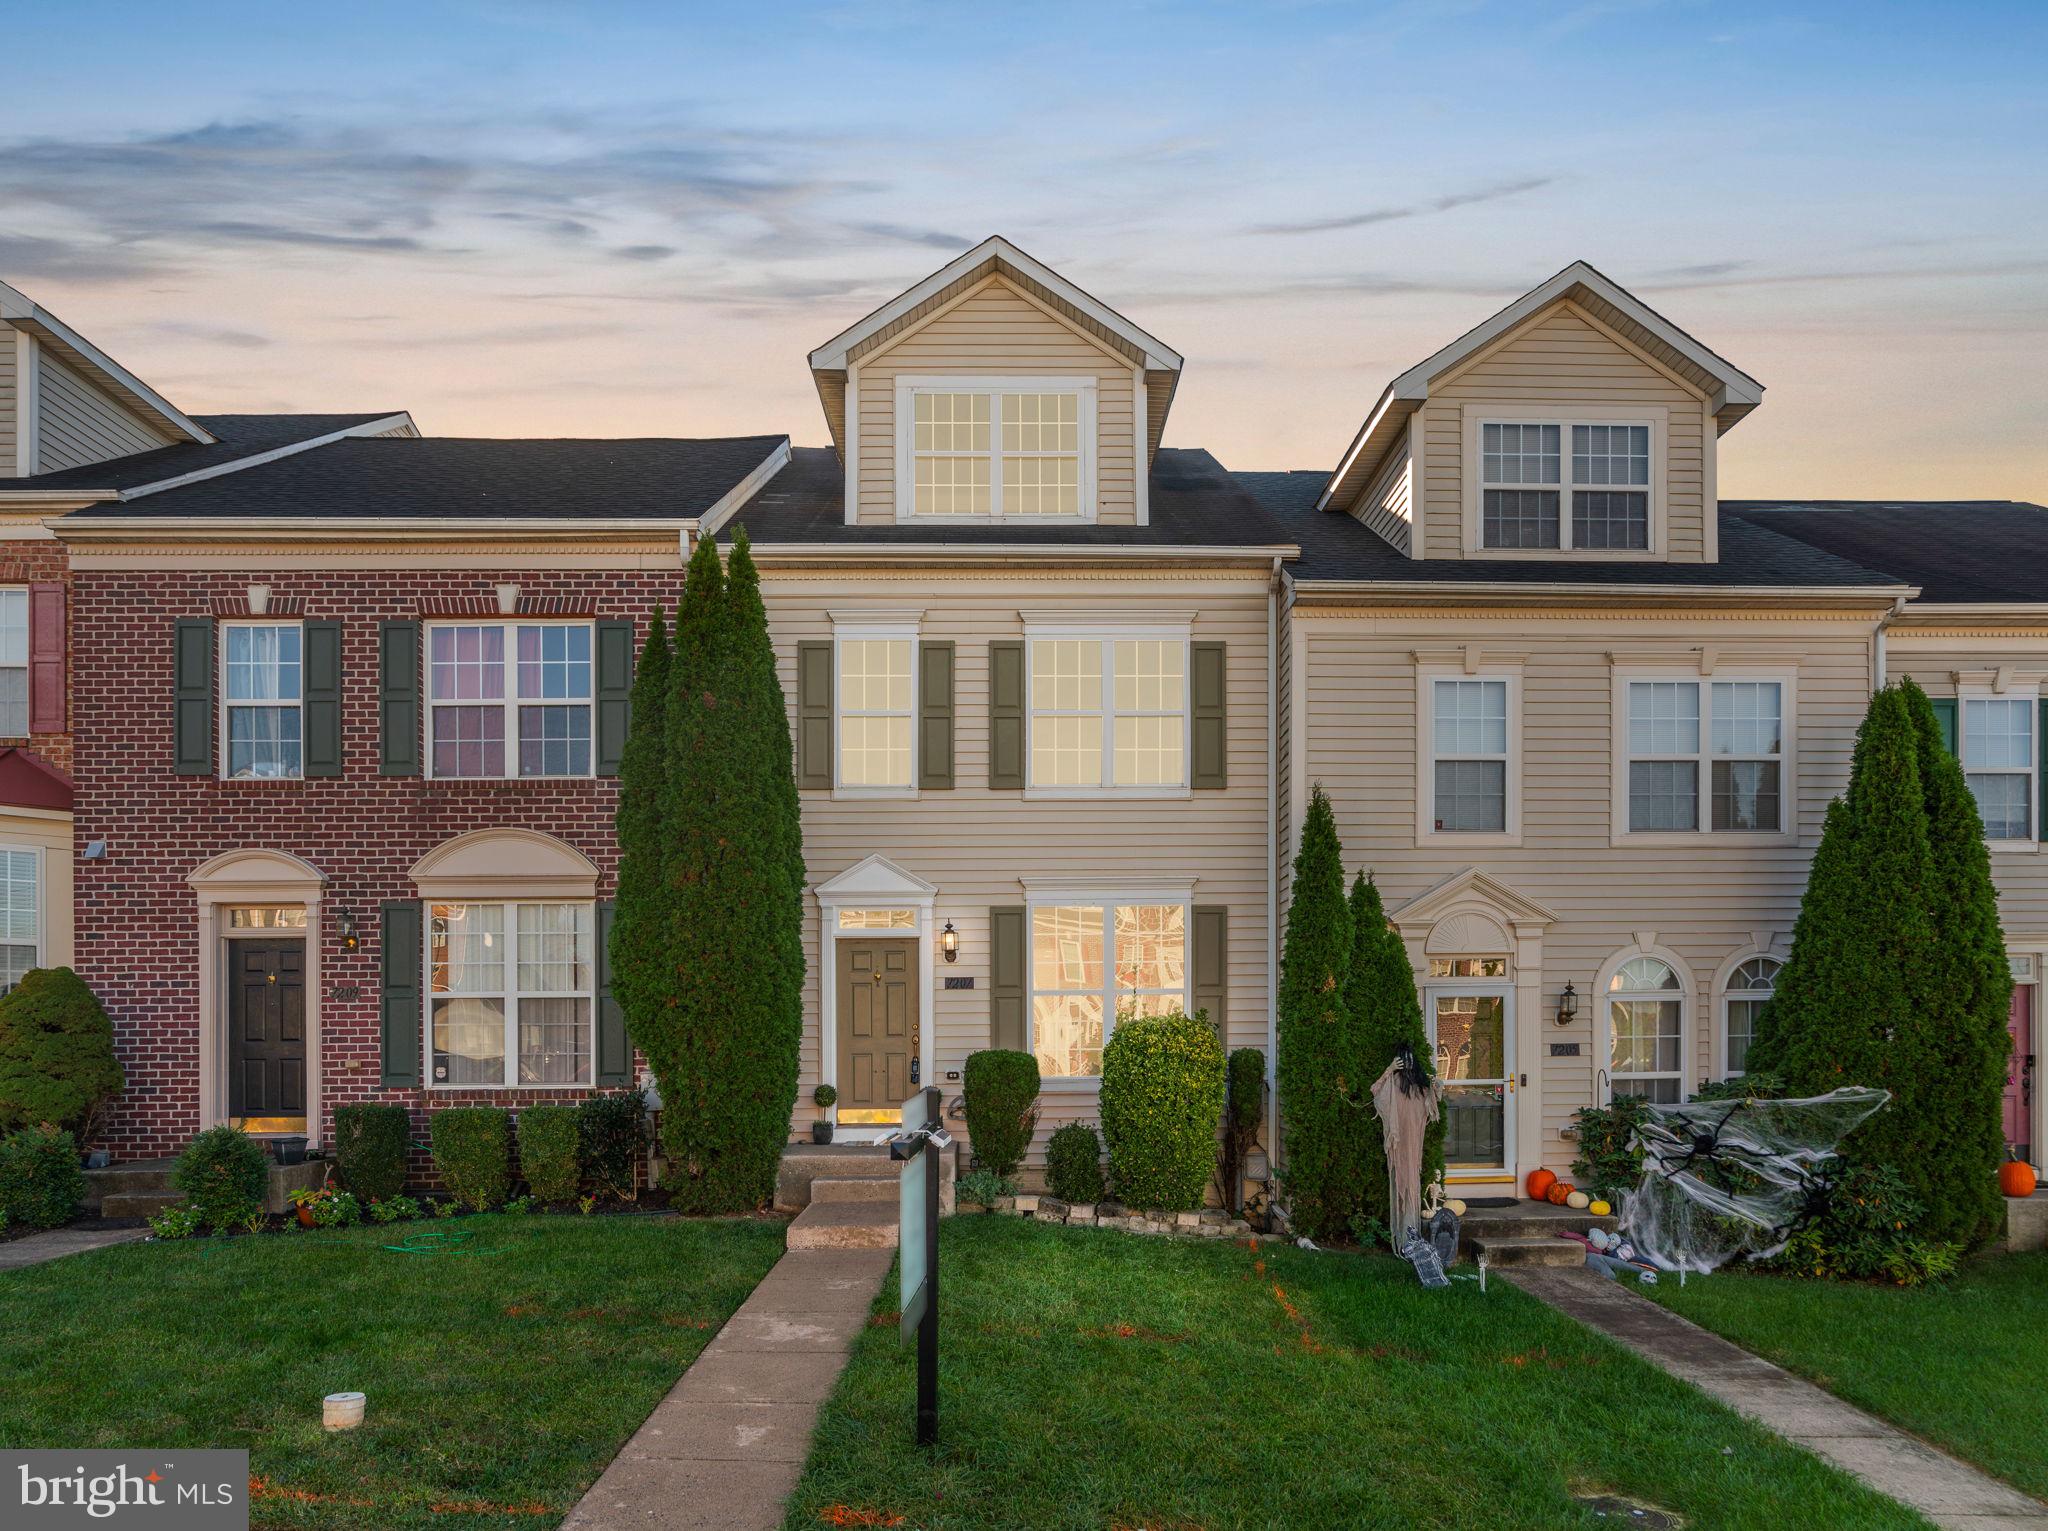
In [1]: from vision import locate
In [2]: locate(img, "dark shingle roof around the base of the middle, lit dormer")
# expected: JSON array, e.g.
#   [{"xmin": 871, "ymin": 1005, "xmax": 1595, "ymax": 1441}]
[{"xmin": 733, "ymin": 446, "xmax": 1292, "ymax": 546}]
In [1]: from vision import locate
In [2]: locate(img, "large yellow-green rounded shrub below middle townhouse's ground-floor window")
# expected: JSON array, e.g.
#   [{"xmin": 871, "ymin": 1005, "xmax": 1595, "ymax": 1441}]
[{"xmin": 1102, "ymin": 1013, "xmax": 1223, "ymax": 1212}]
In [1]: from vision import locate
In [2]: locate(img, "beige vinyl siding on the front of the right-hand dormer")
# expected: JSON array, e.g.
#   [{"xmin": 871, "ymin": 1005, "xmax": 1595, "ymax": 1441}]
[{"xmin": 1419, "ymin": 303, "xmax": 1714, "ymax": 563}]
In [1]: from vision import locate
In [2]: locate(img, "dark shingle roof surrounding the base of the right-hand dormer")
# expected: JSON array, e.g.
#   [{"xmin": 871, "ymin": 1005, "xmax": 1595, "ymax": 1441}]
[{"xmin": 1235, "ymin": 469, "xmax": 1905, "ymax": 589}]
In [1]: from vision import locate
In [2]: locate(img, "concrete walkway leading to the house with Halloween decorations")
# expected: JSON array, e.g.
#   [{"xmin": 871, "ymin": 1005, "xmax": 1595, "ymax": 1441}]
[{"xmin": 1501, "ymin": 1269, "xmax": 2048, "ymax": 1531}]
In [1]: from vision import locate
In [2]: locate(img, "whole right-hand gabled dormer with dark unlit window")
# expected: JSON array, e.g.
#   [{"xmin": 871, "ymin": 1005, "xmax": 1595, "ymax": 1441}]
[{"xmin": 1317, "ymin": 260, "xmax": 1763, "ymax": 563}]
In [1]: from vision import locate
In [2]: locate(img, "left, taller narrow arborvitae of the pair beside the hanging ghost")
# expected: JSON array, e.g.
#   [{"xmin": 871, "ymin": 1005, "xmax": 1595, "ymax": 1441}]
[{"xmin": 1274, "ymin": 786, "xmax": 1372, "ymax": 1238}]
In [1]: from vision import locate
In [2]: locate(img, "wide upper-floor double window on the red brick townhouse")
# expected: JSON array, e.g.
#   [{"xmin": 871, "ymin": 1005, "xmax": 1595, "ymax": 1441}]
[{"xmin": 426, "ymin": 622, "xmax": 592, "ymax": 778}]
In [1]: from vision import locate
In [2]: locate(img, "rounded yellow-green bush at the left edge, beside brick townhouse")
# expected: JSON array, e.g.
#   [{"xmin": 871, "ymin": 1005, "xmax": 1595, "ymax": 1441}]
[{"xmin": 0, "ymin": 968, "xmax": 127, "ymax": 1142}]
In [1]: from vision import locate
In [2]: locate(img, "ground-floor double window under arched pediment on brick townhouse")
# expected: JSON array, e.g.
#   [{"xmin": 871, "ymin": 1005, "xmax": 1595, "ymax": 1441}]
[{"xmin": 426, "ymin": 903, "xmax": 596, "ymax": 1089}]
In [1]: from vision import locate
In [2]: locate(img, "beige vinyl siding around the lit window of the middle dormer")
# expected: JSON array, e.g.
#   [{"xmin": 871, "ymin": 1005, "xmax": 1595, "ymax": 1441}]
[{"xmin": 856, "ymin": 278, "xmax": 1139, "ymax": 526}]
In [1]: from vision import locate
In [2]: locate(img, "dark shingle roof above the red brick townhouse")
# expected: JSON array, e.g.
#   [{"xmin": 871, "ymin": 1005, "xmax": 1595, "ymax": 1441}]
[{"xmin": 78, "ymin": 436, "xmax": 786, "ymax": 520}]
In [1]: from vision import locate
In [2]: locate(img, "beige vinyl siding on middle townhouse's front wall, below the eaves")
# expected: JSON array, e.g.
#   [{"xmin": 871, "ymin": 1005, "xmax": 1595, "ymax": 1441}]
[{"xmin": 764, "ymin": 567, "xmax": 1270, "ymax": 1152}]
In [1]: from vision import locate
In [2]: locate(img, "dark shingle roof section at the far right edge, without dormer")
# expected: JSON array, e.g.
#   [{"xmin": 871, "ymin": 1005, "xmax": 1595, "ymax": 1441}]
[{"xmin": 1720, "ymin": 499, "xmax": 2048, "ymax": 604}]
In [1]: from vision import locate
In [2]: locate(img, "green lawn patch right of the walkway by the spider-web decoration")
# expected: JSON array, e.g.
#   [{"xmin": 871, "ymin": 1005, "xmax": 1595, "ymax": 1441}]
[{"xmin": 1657, "ymin": 1255, "xmax": 2048, "ymax": 1498}]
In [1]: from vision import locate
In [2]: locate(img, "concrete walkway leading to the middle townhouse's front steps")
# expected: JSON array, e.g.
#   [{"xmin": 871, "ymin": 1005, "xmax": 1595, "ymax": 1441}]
[{"xmin": 561, "ymin": 1249, "xmax": 888, "ymax": 1531}]
